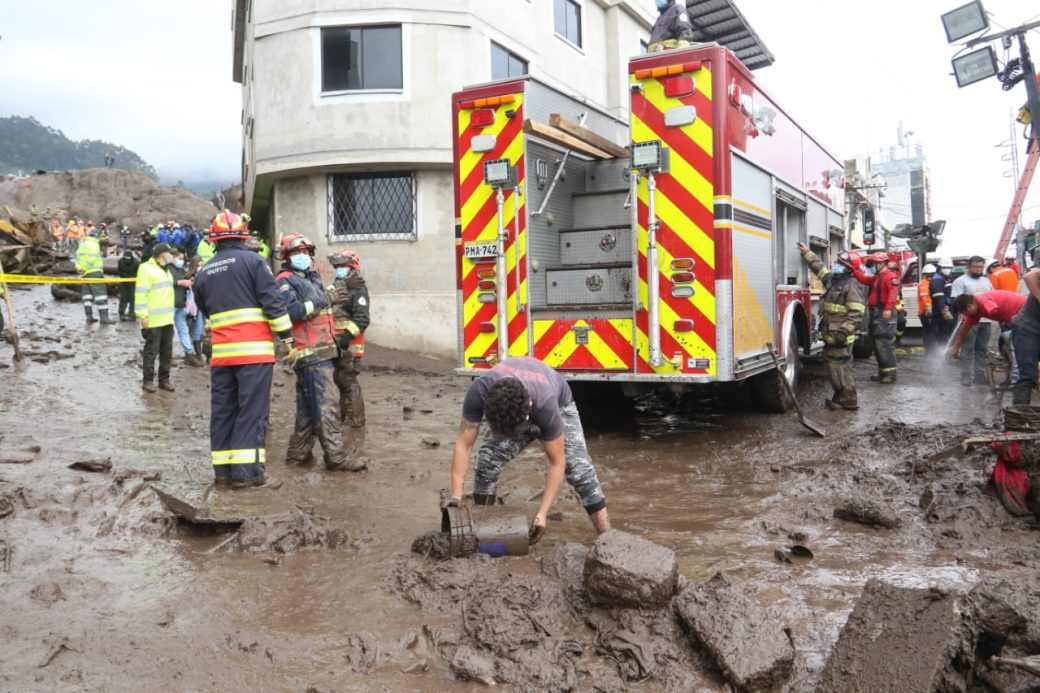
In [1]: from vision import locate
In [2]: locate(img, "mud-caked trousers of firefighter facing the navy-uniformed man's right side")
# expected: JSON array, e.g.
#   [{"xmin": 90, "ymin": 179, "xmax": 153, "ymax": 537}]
[{"xmin": 285, "ymin": 360, "xmax": 346, "ymax": 468}]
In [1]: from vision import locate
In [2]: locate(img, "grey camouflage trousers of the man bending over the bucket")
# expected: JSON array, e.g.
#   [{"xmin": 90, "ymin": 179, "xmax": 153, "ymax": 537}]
[{"xmin": 473, "ymin": 403, "xmax": 606, "ymax": 515}]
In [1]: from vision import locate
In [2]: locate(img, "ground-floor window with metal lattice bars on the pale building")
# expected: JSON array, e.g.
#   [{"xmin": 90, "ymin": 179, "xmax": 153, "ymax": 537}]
[{"xmin": 329, "ymin": 173, "xmax": 416, "ymax": 241}]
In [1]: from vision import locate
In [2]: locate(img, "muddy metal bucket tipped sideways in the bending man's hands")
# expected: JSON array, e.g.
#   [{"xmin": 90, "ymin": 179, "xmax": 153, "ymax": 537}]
[{"xmin": 441, "ymin": 506, "xmax": 530, "ymax": 558}]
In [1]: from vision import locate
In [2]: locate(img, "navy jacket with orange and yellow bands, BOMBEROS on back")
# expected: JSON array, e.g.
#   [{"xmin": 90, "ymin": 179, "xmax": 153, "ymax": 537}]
[{"xmin": 192, "ymin": 240, "xmax": 292, "ymax": 366}]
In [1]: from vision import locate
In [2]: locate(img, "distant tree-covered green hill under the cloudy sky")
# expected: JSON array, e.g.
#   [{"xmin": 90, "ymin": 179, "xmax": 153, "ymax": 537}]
[{"xmin": 0, "ymin": 116, "xmax": 158, "ymax": 180}]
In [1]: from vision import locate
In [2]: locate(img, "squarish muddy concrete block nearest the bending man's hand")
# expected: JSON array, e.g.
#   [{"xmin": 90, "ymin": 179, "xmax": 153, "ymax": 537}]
[{"xmin": 584, "ymin": 530, "xmax": 679, "ymax": 609}]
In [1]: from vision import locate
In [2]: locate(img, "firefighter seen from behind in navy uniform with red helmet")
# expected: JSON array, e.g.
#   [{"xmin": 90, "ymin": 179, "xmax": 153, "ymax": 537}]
[{"xmin": 192, "ymin": 210, "xmax": 296, "ymax": 488}]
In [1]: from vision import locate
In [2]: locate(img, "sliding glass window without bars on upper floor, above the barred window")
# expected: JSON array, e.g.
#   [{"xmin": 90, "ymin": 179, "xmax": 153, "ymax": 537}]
[{"xmin": 321, "ymin": 25, "xmax": 404, "ymax": 92}]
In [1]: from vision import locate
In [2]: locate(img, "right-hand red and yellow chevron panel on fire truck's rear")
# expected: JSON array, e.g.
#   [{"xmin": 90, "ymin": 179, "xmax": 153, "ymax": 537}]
[{"xmin": 630, "ymin": 63, "xmax": 718, "ymax": 375}]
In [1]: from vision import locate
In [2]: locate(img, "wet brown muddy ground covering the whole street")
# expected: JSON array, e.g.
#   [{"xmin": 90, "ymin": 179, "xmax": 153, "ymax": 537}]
[{"xmin": 0, "ymin": 278, "xmax": 1040, "ymax": 691}]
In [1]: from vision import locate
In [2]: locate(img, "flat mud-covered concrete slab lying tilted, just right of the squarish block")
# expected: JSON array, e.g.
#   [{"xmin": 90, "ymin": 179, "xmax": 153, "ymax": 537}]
[{"xmin": 672, "ymin": 572, "xmax": 795, "ymax": 690}]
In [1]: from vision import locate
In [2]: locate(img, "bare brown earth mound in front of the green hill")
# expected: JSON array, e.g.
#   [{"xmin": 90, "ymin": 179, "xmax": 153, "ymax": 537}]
[{"xmin": 0, "ymin": 169, "xmax": 217, "ymax": 231}]
